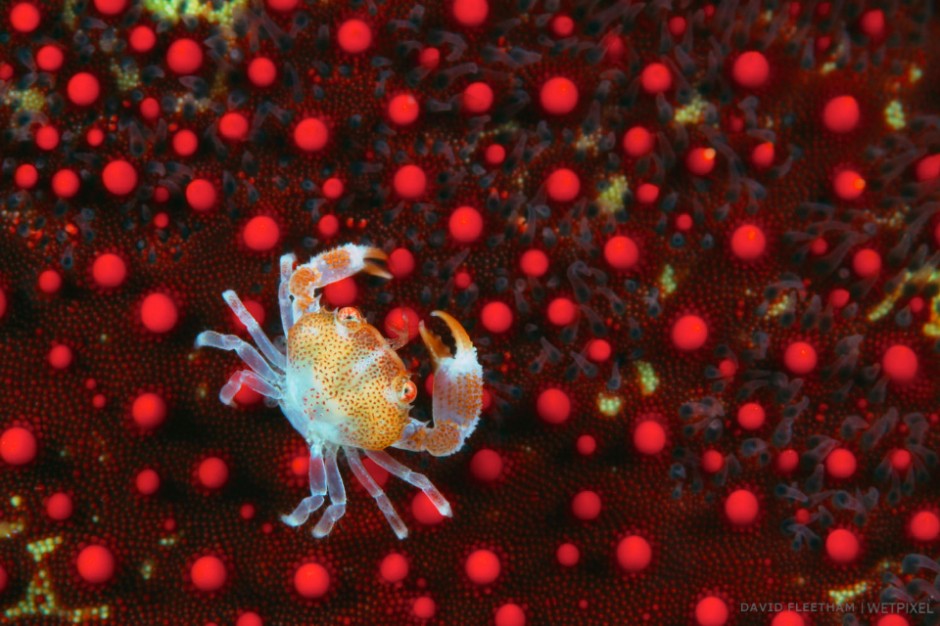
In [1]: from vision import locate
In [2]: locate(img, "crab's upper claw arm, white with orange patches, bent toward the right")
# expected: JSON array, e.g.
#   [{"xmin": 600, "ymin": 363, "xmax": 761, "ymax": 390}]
[{"xmin": 288, "ymin": 244, "xmax": 392, "ymax": 312}]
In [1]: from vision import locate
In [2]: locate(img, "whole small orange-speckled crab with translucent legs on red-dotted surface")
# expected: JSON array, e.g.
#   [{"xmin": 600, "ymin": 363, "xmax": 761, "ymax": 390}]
[{"xmin": 196, "ymin": 244, "xmax": 483, "ymax": 539}]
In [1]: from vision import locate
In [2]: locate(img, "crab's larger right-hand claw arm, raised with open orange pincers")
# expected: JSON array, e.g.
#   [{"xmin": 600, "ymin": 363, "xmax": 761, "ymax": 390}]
[{"xmin": 394, "ymin": 311, "xmax": 483, "ymax": 456}]
